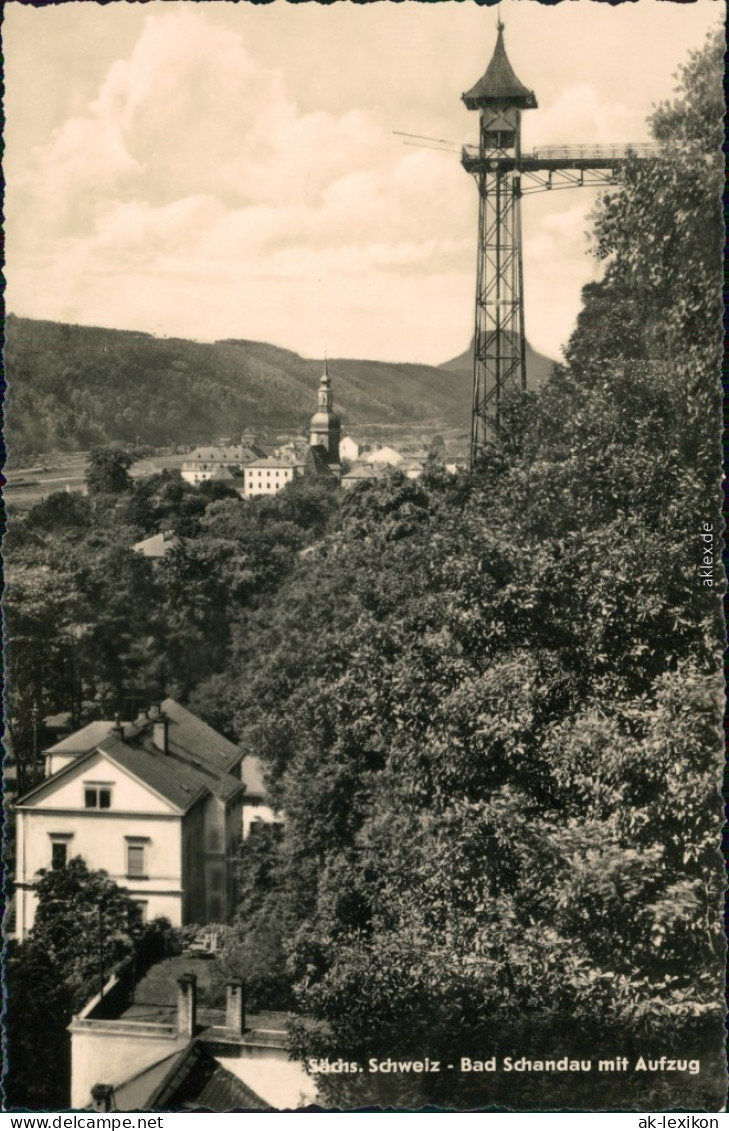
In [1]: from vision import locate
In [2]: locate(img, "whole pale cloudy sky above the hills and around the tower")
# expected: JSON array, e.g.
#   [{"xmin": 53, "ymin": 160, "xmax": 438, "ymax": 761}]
[{"xmin": 3, "ymin": 0, "xmax": 724, "ymax": 364}]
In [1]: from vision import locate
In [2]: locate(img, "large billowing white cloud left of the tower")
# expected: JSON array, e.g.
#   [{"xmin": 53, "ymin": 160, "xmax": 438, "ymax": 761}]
[{"xmin": 9, "ymin": 8, "xmax": 472, "ymax": 360}]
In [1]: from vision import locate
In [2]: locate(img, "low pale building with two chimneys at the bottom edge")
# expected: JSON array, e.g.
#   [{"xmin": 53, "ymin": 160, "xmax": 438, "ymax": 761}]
[{"xmin": 69, "ymin": 958, "xmax": 316, "ymax": 1112}]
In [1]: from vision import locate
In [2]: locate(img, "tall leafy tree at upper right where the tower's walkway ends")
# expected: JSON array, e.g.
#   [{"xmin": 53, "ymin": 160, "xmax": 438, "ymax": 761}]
[{"xmin": 574, "ymin": 28, "xmax": 724, "ymax": 485}]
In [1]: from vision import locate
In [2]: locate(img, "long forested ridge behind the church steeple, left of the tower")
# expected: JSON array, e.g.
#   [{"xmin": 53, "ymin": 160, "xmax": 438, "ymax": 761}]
[{"xmin": 6, "ymin": 314, "xmax": 470, "ymax": 458}]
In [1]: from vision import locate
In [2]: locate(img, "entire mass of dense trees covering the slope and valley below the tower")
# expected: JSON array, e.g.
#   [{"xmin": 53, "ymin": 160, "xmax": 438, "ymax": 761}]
[{"xmin": 4, "ymin": 26, "xmax": 724, "ymax": 1110}]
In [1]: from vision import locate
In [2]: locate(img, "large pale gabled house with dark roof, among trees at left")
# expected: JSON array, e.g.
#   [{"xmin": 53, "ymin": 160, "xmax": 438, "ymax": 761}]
[{"xmin": 16, "ymin": 699, "xmax": 274, "ymax": 939}]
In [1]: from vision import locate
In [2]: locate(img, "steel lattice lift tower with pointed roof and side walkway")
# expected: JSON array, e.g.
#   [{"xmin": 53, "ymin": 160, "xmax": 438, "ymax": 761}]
[{"xmin": 461, "ymin": 21, "xmax": 663, "ymax": 467}]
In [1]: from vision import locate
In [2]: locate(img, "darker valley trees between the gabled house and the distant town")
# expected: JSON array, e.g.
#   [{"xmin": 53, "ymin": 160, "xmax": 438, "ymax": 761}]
[{"xmin": 5, "ymin": 472, "xmax": 337, "ymax": 791}]
